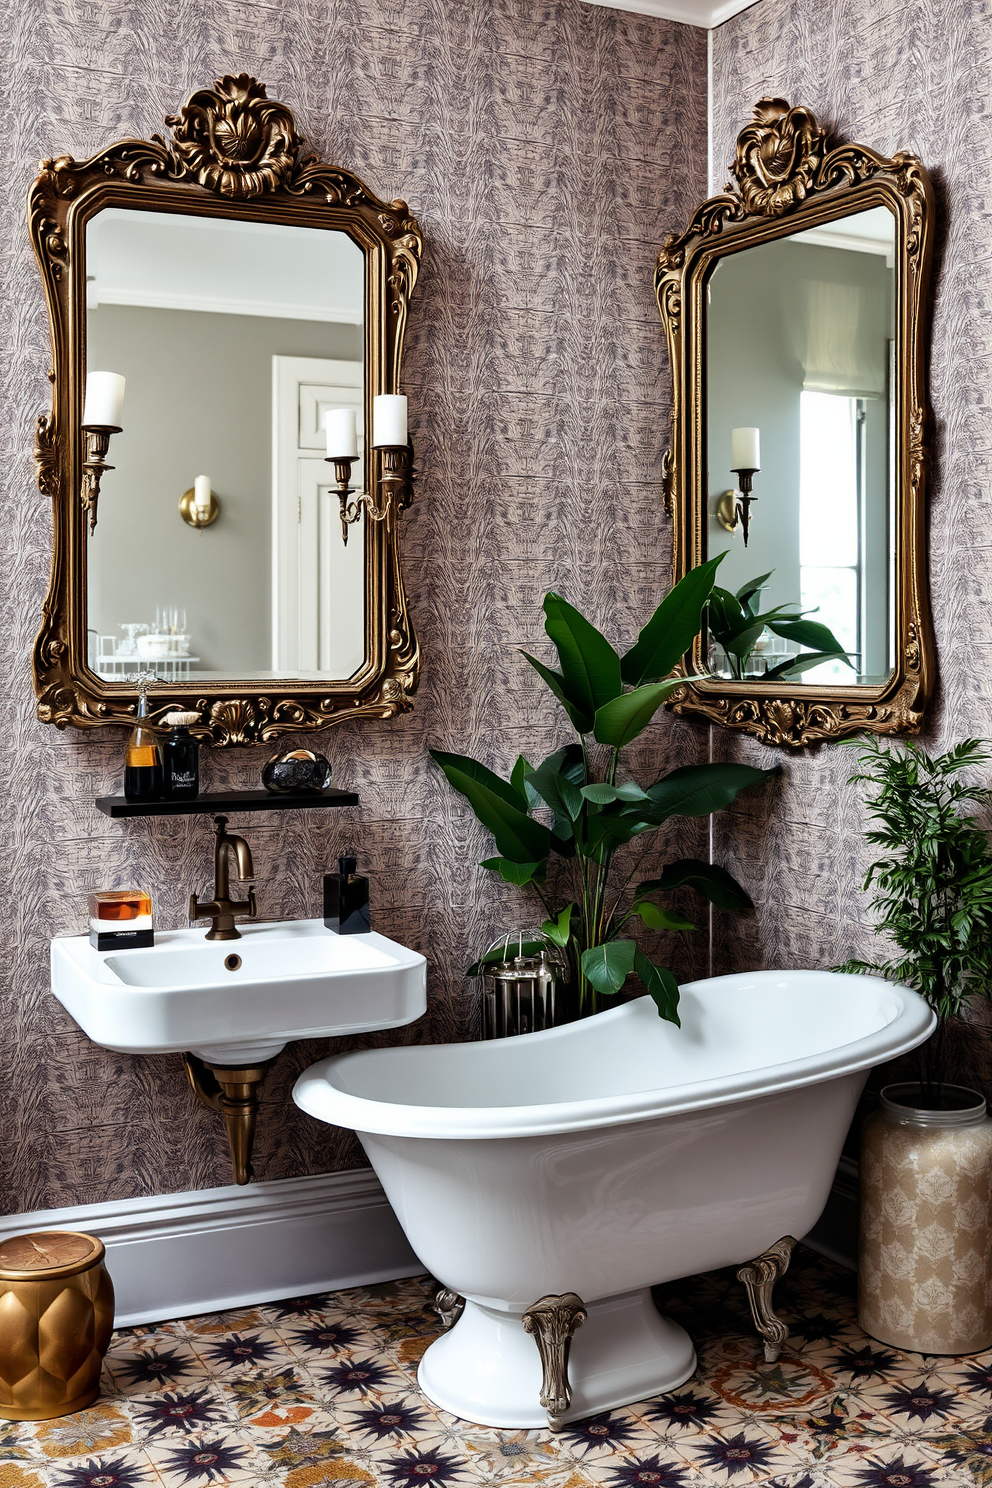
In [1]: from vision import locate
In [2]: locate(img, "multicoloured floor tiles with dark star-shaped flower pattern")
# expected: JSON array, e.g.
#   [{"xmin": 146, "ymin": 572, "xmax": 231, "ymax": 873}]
[{"xmin": 0, "ymin": 1248, "xmax": 992, "ymax": 1488}]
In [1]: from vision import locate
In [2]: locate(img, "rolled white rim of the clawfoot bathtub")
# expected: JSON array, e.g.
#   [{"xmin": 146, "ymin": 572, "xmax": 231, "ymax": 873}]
[{"xmin": 293, "ymin": 969, "xmax": 937, "ymax": 1141}]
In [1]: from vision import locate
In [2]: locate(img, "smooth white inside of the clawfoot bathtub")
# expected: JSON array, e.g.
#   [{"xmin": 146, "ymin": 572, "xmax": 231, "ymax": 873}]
[{"xmin": 325, "ymin": 972, "xmax": 904, "ymax": 1110}]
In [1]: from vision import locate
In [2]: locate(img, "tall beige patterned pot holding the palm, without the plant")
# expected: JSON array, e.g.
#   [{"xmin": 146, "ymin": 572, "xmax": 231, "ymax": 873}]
[{"xmin": 858, "ymin": 1085, "xmax": 992, "ymax": 1354}]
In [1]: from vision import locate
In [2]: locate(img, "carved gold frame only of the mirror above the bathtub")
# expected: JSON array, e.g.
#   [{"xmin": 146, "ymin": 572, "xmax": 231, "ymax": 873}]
[{"xmin": 654, "ymin": 98, "xmax": 935, "ymax": 747}]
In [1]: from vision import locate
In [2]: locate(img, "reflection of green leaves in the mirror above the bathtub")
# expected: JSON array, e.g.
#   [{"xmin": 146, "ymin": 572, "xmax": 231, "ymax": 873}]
[{"xmin": 706, "ymin": 568, "xmax": 852, "ymax": 682}]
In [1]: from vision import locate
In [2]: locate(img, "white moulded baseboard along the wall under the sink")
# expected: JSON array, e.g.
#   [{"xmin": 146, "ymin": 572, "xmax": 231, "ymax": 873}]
[{"xmin": 0, "ymin": 1168, "xmax": 424, "ymax": 1327}]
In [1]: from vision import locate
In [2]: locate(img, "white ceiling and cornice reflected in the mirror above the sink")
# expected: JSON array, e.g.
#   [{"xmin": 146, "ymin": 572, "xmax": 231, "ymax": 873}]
[{"xmin": 86, "ymin": 207, "xmax": 364, "ymax": 324}]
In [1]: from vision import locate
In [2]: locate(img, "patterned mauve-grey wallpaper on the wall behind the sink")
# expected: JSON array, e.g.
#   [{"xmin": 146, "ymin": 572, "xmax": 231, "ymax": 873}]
[{"xmin": 0, "ymin": 0, "xmax": 710, "ymax": 1211}]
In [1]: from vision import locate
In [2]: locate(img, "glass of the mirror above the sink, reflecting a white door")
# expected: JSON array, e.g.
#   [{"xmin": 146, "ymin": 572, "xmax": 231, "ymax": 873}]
[{"xmin": 86, "ymin": 207, "xmax": 366, "ymax": 684}]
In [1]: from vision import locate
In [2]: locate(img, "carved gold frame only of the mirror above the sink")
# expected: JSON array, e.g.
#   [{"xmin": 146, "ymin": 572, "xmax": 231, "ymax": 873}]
[{"xmin": 28, "ymin": 74, "xmax": 422, "ymax": 744}]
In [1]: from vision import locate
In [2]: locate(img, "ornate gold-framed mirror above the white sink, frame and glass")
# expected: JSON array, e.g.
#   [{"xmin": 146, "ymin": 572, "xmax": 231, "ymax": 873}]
[{"xmin": 30, "ymin": 76, "xmax": 421, "ymax": 744}]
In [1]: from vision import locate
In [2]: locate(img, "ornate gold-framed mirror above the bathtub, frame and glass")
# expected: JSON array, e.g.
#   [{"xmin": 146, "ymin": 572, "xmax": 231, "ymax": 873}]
[{"xmin": 656, "ymin": 98, "xmax": 934, "ymax": 745}]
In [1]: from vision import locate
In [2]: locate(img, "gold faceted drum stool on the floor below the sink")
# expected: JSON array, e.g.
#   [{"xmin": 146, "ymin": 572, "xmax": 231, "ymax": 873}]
[{"xmin": 0, "ymin": 1229, "xmax": 113, "ymax": 1421}]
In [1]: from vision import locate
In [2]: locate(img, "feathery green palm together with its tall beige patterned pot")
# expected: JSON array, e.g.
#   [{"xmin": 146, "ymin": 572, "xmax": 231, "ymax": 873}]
[{"xmin": 839, "ymin": 740, "xmax": 992, "ymax": 1354}]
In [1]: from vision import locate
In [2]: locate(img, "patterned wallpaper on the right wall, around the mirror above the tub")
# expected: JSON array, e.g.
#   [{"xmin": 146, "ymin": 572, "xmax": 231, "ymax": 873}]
[{"xmin": 712, "ymin": 0, "xmax": 992, "ymax": 1098}]
